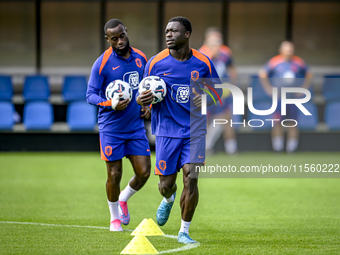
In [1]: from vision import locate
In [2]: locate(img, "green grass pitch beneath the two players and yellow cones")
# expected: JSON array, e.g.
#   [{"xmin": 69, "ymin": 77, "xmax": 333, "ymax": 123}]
[{"xmin": 0, "ymin": 153, "xmax": 340, "ymax": 254}]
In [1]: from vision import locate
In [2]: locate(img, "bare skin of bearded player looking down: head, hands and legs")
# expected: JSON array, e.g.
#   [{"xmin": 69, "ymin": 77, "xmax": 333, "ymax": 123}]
[{"xmin": 105, "ymin": 24, "xmax": 151, "ymax": 202}]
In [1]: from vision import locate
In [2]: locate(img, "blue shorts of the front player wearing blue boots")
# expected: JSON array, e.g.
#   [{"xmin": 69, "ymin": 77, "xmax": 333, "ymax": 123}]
[{"xmin": 155, "ymin": 135, "xmax": 205, "ymax": 175}]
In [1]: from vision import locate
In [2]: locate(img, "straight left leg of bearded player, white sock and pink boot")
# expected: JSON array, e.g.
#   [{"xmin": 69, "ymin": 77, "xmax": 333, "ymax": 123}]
[{"xmin": 106, "ymin": 159, "xmax": 123, "ymax": 231}]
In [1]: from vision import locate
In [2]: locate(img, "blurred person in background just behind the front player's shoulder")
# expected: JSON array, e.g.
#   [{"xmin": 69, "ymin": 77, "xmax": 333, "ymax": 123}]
[{"xmin": 199, "ymin": 27, "xmax": 237, "ymax": 154}]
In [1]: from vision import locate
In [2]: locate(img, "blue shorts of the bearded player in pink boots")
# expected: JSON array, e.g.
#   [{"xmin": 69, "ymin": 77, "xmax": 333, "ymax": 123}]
[{"xmin": 99, "ymin": 130, "xmax": 150, "ymax": 161}]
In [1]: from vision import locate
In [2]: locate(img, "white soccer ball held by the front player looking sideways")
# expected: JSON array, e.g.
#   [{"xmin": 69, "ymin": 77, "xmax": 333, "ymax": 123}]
[{"xmin": 138, "ymin": 76, "xmax": 166, "ymax": 104}]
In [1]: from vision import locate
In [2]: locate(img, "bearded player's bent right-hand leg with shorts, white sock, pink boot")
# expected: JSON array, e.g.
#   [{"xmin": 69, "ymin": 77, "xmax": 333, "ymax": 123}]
[{"xmin": 119, "ymin": 134, "xmax": 151, "ymax": 225}]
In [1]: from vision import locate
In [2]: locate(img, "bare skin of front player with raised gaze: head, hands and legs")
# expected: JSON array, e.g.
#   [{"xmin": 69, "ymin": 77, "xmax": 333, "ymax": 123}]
[{"xmin": 137, "ymin": 21, "xmax": 201, "ymax": 221}]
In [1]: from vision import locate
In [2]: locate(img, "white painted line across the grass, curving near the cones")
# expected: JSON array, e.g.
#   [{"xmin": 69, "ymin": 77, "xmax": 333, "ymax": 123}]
[{"xmin": 0, "ymin": 221, "xmax": 200, "ymax": 254}]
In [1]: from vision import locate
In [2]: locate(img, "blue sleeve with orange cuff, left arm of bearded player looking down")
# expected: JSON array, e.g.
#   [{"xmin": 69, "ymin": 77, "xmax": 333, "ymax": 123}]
[{"xmin": 86, "ymin": 58, "xmax": 111, "ymax": 108}]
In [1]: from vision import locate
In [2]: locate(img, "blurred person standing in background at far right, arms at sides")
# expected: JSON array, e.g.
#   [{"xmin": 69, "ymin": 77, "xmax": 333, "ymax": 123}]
[{"xmin": 259, "ymin": 41, "xmax": 312, "ymax": 153}]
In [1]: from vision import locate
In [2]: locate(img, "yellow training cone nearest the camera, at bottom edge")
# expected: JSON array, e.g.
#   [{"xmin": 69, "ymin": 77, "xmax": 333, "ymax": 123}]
[{"xmin": 120, "ymin": 235, "xmax": 158, "ymax": 254}]
